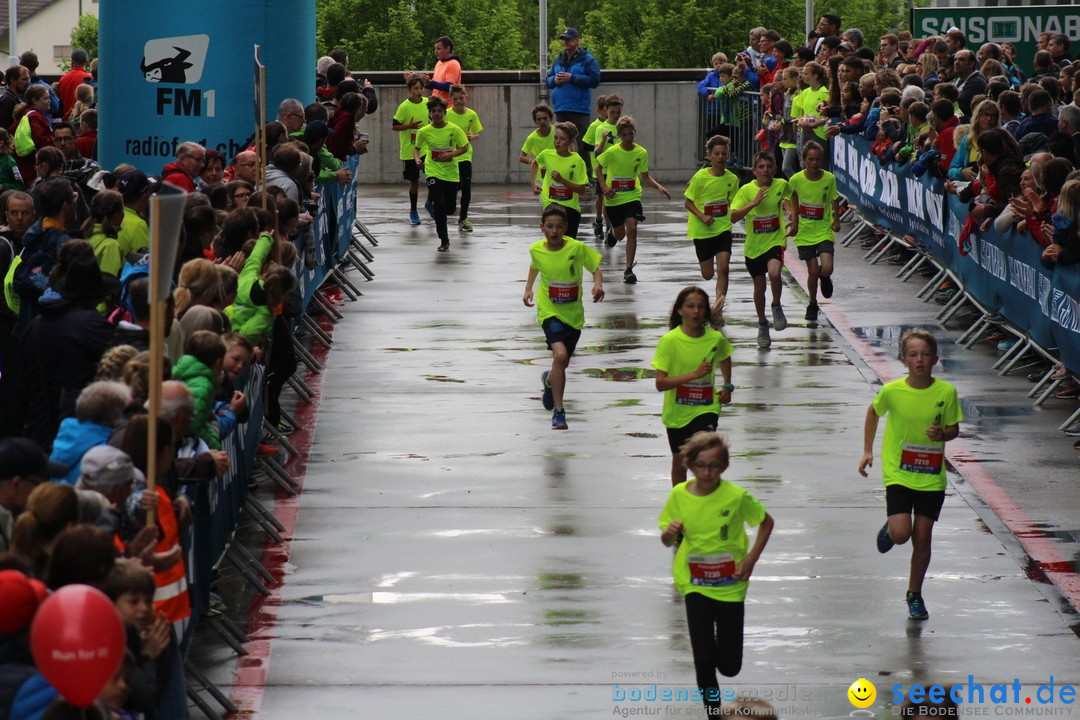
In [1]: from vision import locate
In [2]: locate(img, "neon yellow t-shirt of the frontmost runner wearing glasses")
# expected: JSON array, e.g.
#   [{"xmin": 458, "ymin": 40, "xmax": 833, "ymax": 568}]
[{"xmin": 659, "ymin": 479, "xmax": 766, "ymax": 602}]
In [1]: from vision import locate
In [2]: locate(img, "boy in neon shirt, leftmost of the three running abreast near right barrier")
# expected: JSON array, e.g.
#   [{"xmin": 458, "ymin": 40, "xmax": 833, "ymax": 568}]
[{"xmin": 683, "ymin": 135, "xmax": 739, "ymax": 315}]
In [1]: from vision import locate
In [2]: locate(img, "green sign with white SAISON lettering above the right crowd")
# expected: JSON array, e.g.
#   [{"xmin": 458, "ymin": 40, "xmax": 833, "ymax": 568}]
[{"xmin": 912, "ymin": 5, "xmax": 1080, "ymax": 74}]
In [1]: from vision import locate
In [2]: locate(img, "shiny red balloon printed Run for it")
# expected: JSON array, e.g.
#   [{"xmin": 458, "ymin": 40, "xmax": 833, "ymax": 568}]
[{"xmin": 30, "ymin": 585, "xmax": 124, "ymax": 707}]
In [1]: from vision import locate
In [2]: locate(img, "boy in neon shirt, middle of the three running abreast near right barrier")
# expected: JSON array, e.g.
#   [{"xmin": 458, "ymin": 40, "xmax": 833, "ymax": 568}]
[{"xmin": 731, "ymin": 152, "xmax": 798, "ymax": 350}]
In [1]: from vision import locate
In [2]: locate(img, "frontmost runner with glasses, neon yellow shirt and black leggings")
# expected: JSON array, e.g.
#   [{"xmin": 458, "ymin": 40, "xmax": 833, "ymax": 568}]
[{"xmin": 658, "ymin": 433, "xmax": 774, "ymax": 717}]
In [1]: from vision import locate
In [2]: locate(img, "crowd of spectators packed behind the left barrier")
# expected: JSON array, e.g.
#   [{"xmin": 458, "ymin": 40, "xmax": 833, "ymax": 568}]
[{"xmin": 0, "ymin": 50, "xmax": 378, "ymax": 720}]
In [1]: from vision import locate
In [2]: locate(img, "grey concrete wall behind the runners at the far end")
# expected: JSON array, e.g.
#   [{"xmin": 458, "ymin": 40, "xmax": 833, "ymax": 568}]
[{"xmin": 360, "ymin": 80, "xmax": 704, "ymax": 185}]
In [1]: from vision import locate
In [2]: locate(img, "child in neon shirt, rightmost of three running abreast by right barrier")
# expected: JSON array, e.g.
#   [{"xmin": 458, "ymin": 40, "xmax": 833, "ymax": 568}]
[{"xmin": 788, "ymin": 140, "xmax": 840, "ymax": 323}]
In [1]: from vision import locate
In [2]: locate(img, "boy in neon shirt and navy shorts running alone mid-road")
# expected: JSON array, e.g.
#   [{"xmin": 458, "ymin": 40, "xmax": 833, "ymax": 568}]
[{"xmin": 522, "ymin": 204, "xmax": 604, "ymax": 430}]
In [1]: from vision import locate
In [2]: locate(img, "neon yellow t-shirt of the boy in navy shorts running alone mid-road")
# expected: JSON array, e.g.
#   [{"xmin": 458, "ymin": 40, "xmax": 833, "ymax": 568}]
[{"xmin": 529, "ymin": 237, "xmax": 603, "ymax": 330}]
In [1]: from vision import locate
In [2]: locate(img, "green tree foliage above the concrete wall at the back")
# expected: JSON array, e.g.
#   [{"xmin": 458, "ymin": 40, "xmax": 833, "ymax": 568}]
[{"xmin": 315, "ymin": 0, "xmax": 929, "ymax": 70}]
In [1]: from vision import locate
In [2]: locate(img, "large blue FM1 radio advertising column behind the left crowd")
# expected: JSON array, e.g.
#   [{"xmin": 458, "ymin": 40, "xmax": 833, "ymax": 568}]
[{"xmin": 97, "ymin": 0, "xmax": 315, "ymax": 174}]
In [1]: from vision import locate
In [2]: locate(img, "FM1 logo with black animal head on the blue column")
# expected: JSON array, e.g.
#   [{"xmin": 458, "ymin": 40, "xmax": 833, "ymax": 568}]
[{"xmin": 139, "ymin": 35, "xmax": 215, "ymax": 118}]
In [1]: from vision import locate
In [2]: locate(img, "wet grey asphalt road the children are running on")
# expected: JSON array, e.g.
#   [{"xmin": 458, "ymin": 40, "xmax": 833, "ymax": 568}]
[{"xmin": 215, "ymin": 182, "xmax": 1080, "ymax": 720}]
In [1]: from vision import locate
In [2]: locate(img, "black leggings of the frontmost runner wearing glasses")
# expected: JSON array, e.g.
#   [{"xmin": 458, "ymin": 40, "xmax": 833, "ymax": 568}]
[{"xmin": 686, "ymin": 593, "xmax": 745, "ymax": 717}]
